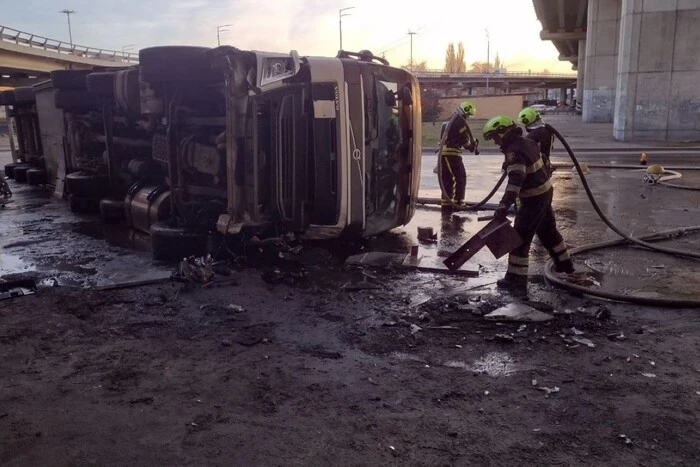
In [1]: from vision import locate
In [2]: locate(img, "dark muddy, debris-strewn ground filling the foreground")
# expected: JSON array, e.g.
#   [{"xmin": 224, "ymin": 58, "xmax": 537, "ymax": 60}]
[{"xmin": 0, "ymin": 250, "xmax": 700, "ymax": 465}]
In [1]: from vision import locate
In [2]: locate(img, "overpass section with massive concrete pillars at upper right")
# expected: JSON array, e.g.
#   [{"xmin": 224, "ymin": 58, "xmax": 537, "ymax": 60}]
[{"xmin": 533, "ymin": 0, "xmax": 700, "ymax": 141}]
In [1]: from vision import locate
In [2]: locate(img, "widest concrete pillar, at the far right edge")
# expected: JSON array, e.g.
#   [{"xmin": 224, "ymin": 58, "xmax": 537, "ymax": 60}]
[{"xmin": 613, "ymin": 0, "xmax": 700, "ymax": 141}]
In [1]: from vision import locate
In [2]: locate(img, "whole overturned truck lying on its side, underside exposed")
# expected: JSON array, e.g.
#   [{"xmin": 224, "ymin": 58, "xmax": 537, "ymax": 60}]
[{"xmin": 0, "ymin": 46, "xmax": 421, "ymax": 259}]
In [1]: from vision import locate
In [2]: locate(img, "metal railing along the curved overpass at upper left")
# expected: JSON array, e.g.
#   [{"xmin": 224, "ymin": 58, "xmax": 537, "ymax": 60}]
[{"xmin": 0, "ymin": 26, "xmax": 139, "ymax": 64}]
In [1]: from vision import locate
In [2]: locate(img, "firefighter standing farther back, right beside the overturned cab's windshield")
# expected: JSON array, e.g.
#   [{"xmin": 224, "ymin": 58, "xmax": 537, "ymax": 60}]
[{"xmin": 438, "ymin": 101, "xmax": 478, "ymax": 208}]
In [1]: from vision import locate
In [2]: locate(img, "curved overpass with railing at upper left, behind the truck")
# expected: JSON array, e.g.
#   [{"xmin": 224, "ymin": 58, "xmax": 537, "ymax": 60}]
[{"xmin": 0, "ymin": 26, "xmax": 138, "ymax": 87}]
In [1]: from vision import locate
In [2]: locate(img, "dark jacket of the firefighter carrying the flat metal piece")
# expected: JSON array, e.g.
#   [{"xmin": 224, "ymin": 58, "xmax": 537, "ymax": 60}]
[{"xmin": 499, "ymin": 128, "xmax": 552, "ymax": 208}]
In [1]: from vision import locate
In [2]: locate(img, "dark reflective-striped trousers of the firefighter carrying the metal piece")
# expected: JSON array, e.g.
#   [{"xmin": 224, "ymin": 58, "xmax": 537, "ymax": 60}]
[{"xmin": 506, "ymin": 188, "xmax": 573, "ymax": 281}]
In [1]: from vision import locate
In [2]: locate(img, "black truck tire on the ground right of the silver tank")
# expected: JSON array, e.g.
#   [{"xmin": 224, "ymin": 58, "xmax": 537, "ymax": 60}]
[{"xmin": 151, "ymin": 221, "xmax": 209, "ymax": 261}]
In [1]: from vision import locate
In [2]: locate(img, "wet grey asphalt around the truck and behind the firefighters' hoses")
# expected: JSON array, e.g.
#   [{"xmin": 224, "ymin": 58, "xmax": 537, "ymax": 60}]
[{"xmin": 0, "ymin": 144, "xmax": 700, "ymax": 304}]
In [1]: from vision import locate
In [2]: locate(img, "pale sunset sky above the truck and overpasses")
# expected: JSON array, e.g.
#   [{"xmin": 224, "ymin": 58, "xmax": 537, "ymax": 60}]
[{"xmin": 0, "ymin": 0, "xmax": 572, "ymax": 73}]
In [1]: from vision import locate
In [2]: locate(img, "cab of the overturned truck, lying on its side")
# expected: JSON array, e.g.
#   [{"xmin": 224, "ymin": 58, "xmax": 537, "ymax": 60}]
[{"xmin": 210, "ymin": 47, "xmax": 421, "ymax": 238}]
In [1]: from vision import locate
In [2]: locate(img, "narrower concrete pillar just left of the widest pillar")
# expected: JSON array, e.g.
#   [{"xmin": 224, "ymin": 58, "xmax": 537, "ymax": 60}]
[{"xmin": 583, "ymin": 0, "xmax": 623, "ymax": 123}]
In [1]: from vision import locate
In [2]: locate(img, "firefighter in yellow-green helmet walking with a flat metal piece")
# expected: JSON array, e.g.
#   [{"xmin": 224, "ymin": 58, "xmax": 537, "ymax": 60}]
[{"xmin": 484, "ymin": 115, "xmax": 574, "ymax": 292}]
